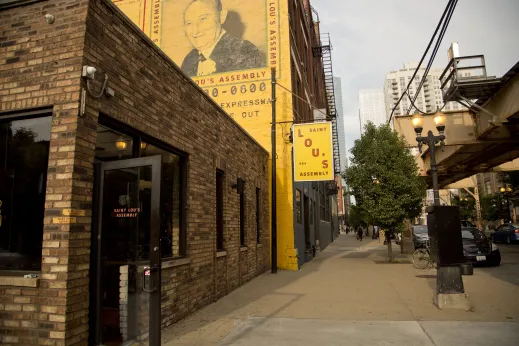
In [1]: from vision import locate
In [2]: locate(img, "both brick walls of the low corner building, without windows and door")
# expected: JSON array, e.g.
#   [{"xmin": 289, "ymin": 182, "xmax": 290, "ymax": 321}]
[{"xmin": 0, "ymin": 0, "xmax": 270, "ymax": 345}]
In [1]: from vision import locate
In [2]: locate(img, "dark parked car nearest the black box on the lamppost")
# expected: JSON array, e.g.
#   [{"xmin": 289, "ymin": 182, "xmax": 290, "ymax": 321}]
[{"xmin": 461, "ymin": 227, "xmax": 501, "ymax": 266}]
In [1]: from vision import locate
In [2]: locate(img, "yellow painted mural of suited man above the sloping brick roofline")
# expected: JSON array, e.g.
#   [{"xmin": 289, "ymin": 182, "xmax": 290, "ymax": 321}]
[{"xmin": 114, "ymin": 0, "xmax": 289, "ymax": 139}]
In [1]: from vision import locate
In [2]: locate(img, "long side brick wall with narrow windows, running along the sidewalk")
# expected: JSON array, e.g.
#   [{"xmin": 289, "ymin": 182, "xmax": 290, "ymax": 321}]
[{"xmin": 85, "ymin": 1, "xmax": 270, "ymax": 332}]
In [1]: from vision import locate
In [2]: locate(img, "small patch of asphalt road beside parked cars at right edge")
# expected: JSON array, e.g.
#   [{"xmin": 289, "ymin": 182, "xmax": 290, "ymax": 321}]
[{"xmin": 474, "ymin": 244, "xmax": 519, "ymax": 286}]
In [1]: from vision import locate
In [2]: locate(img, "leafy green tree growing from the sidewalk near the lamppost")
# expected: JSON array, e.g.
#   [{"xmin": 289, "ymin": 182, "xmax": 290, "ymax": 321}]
[{"xmin": 343, "ymin": 123, "xmax": 427, "ymax": 261}]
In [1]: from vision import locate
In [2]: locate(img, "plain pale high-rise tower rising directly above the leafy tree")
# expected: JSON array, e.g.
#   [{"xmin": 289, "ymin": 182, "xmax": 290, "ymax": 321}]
[{"xmin": 359, "ymin": 89, "xmax": 387, "ymax": 133}]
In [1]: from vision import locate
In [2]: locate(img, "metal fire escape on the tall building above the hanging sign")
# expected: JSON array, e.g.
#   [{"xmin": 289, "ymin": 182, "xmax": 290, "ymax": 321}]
[{"xmin": 313, "ymin": 34, "xmax": 341, "ymax": 175}]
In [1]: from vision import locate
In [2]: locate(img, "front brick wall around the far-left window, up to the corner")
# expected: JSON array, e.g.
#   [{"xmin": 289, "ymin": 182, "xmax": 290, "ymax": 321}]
[{"xmin": 0, "ymin": 0, "xmax": 92, "ymax": 345}]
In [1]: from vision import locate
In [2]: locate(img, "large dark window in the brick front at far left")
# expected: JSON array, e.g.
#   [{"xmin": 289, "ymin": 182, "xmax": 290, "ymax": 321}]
[{"xmin": 0, "ymin": 116, "xmax": 52, "ymax": 270}]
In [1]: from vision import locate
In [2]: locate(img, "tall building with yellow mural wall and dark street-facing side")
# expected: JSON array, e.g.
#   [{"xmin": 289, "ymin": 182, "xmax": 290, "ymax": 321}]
[{"xmin": 110, "ymin": 0, "xmax": 340, "ymax": 270}]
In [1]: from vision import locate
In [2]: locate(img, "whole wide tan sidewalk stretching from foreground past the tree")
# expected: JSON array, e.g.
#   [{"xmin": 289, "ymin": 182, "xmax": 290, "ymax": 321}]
[{"xmin": 163, "ymin": 234, "xmax": 519, "ymax": 346}]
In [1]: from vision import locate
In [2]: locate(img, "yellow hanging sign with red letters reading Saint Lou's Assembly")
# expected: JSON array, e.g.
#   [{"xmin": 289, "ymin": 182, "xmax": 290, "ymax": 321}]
[{"xmin": 293, "ymin": 122, "xmax": 334, "ymax": 181}]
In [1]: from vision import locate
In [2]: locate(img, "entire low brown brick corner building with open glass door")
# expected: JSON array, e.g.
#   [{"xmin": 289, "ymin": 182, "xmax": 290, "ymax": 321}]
[{"xmin": 0, "ymin": 0, "xmax": 270, "ymax": 345}]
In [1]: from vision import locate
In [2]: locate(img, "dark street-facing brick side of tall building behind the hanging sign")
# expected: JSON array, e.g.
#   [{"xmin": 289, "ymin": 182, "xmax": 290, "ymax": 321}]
[{"xmin": 288, "ymin": 0, "xmax": 342, "ymax": 266}]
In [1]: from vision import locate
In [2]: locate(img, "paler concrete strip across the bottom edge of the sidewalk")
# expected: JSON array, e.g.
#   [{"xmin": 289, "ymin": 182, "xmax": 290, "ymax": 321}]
[{"xmin": 222, "ymin": 317, "xmax": 518, "ymax": 346}]
